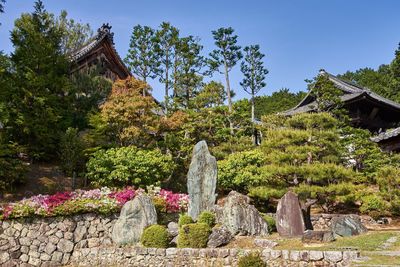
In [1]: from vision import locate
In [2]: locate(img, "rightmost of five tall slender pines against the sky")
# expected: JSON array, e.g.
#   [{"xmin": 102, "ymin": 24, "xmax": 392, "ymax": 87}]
[{"xmin": 240, "ymin": 45, "xmax": 268, "ymax": 144}]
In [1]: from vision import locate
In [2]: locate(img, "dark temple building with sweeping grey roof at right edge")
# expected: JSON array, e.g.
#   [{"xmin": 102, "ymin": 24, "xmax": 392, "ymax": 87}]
[{"xmin": 284, "ymin": 70, "xmax": 400, "ymax": 151}]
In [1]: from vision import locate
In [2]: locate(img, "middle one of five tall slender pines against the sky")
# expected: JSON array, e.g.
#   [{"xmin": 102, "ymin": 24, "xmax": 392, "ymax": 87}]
[{"xmin": 174, "ymin": 36, "xmax": 204, "ymax": 109}]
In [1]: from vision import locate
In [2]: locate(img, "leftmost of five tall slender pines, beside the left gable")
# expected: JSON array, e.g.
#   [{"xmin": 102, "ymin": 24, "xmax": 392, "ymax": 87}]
[{"xmin": 125, "ymin": 25, "xmax": 160, "ymax": 93}]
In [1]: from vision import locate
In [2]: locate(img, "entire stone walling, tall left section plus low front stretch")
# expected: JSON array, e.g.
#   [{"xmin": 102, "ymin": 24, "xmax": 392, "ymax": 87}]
[{"xmin": 0, "ymin": 214, "xmax": 357, "ymax": 267}]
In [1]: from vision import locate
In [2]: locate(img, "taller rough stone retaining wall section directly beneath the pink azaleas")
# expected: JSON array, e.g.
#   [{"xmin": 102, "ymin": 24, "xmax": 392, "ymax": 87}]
[{"xmin": 0, "ymin": 214, "xmax": 117, "ymax": 266}]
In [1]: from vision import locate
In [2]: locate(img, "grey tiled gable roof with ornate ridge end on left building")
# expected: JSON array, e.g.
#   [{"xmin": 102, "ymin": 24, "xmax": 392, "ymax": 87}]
[{"xmin": 70, "ymin": 23, "xmax": 131, "ymax": 79}]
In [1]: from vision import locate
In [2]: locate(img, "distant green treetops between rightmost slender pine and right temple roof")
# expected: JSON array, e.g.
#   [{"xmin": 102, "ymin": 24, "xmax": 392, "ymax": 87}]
[{"xmin": 254, "ymin": 88, "xmax": 306, "ymax": 119}]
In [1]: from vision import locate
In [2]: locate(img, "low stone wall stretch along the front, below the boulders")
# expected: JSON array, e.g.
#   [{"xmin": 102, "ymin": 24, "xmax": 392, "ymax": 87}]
[{"xmin": 71, "ymin": 247, "xmax": 359, "ymax": 267}]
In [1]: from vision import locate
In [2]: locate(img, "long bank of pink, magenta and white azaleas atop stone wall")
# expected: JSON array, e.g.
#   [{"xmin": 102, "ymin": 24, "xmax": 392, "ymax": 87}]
[{"xmin": 0, "ymin": 187, "xmax": 188, "ymax": 219}]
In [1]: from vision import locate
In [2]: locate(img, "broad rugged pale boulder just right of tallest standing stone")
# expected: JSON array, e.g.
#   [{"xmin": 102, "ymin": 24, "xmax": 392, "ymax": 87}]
[{"xmin": 214, "ymin": 191, "xmax": 268, "ymax": 236}]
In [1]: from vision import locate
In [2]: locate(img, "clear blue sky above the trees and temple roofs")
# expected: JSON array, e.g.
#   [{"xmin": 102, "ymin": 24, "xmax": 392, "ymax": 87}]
[{"xmin": 0, "ymin": 0, "xmax": 400, "ymax": 99}]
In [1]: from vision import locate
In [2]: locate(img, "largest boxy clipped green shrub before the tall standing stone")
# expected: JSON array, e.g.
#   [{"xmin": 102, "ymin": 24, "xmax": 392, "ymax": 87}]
[{"xmin": 178, "ymin": 223, "xmax": 211, "ymax": 248}]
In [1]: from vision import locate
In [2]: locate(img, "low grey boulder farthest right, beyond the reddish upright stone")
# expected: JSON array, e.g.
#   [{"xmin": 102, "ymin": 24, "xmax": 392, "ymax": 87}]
[{"xmin": 331, "ymin": 215, "xmax": 368, "ymax": 239}]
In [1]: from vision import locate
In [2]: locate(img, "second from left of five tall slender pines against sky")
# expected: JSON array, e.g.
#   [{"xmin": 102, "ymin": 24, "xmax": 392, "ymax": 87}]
[{"xmin": 156, "ymin": 22, "xmax": 179, "ymax": 115}]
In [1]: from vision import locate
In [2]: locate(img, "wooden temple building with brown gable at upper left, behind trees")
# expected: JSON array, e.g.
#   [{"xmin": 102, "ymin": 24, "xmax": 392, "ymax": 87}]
[{"xmin": 70, "ymin": 23, "xmax": 131, "ymax": 81}]
